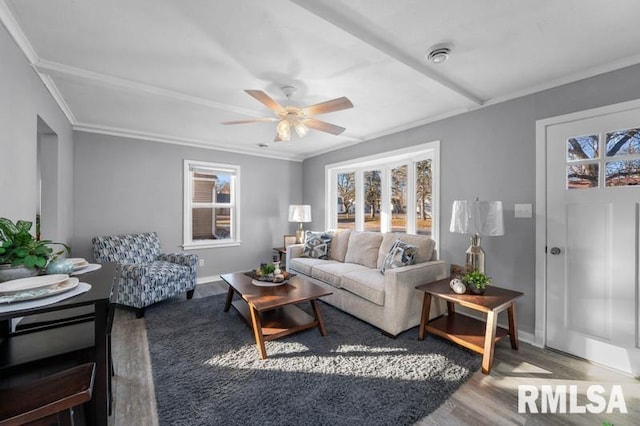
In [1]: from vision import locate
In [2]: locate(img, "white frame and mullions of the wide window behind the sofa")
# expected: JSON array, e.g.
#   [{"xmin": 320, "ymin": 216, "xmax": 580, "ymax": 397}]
[{"xmin": 325, "ymin": 141, "xmax": 440, "ymax": 248}]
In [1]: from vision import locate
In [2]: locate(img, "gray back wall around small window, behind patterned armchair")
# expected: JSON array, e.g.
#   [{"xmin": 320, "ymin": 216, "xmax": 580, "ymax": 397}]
[{"xmin": 73, "ymin": 132, "xmax": 302, "ymax": 277}]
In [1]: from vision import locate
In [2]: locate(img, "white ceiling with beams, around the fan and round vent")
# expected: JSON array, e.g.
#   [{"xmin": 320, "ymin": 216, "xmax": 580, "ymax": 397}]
[{"xmin": 0, "ymin": 0, "xmax": 640, "ymax": 160}]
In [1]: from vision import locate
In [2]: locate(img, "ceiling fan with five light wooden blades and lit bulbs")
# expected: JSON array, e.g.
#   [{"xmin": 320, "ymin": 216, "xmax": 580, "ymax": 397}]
[{"xmin": 222, "ymin": 86, "xmax": 353, "ymax": 142}]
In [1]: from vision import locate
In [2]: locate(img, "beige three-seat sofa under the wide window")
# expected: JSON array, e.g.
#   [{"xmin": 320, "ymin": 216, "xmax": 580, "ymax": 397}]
[{"xmin": 287, "ymin": 230, "xmax": 446, "ymax": 336}]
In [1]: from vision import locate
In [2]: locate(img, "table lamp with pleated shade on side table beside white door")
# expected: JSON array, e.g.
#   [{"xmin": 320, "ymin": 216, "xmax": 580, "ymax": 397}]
[{"xmin": 449, "ymin": 199, "xmax": 504, "ymax": 272}]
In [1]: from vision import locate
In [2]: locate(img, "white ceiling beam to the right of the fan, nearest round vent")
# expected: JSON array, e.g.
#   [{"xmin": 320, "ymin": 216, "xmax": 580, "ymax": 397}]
[{"xmin": 290, "ymin": 0, "xmax": 484, "ymax": 105}]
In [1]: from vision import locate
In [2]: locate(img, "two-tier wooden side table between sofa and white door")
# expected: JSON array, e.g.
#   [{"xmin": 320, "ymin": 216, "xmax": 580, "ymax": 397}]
[{"xmin": 416, "ymin": 278, "xmax": 524, "ymax": 374}]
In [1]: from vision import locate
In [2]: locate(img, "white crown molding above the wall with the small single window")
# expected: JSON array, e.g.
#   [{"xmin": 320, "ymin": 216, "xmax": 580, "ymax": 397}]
[{"xmin": 73, "ymin": 123, "xmax": 304, "ymax": 161}]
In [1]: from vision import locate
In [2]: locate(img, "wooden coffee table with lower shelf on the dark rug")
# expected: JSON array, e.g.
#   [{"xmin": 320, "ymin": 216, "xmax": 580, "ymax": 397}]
[{"xmin": 221, "ymin": 272, "xmax": 331, "ymax": 359}]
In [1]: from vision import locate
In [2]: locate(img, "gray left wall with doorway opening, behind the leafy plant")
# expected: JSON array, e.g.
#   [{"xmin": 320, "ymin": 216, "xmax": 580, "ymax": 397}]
[{"xmin": 0, "ymin": 21, "xmax": 73, "ymax": 242}]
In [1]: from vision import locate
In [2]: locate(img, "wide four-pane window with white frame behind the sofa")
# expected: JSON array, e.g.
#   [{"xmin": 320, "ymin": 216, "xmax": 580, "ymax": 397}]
[{"xmin": 325, "ymin": 142, "xmax": 439, "ymax": 241}]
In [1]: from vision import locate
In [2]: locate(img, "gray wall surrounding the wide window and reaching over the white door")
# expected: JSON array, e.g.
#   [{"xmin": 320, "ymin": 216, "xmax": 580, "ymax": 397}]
[{"xmin": 303, "ymin": 65, "xmax": 640, "ymax": 334}]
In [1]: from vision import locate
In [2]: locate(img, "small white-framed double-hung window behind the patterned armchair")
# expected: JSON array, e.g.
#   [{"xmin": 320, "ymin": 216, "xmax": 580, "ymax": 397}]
[{"xmin": 183, "ymin": 160, "xmax": 240, "ymax": 249}]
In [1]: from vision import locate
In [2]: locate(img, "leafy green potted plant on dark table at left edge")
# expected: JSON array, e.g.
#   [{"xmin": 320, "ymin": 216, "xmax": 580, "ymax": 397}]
[{"xmin": 0, "ymin": 217, "xmax": 70, "ymax": 282}]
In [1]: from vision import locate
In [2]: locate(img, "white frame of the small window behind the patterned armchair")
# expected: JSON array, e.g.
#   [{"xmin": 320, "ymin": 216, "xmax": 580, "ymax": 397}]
[{"xmin": 182, "ymin": 160, "xmax": 242, "ymax": 250}]
